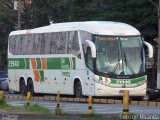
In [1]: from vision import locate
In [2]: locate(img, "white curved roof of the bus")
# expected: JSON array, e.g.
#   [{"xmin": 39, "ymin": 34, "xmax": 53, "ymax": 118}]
[{"xmin": 10, "ymin": 21, "xmax": 140, "ymax": 36}]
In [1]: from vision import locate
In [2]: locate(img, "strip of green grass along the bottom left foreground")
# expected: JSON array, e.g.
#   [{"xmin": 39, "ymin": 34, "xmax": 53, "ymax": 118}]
[{"xmin": 0, "ymin": 100, "xmax": 120, "ymax": 120}]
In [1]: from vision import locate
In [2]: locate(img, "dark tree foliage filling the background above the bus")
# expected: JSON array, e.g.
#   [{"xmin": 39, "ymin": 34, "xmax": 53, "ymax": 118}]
[{"xmin": 0, "ymin": 0, "xmax": 158, "ymax": 69}]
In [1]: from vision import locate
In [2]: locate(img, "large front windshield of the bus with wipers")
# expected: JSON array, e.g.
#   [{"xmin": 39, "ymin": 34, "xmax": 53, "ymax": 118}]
[{"xmin": 94, "ymin": 35, "xmax": 145, "ymax": 75}]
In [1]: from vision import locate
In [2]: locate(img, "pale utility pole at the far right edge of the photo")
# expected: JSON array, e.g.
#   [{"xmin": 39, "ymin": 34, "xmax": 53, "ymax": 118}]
[{"xmin": 157, "ymin": 0, "xmax": 160, "ymax": 89}]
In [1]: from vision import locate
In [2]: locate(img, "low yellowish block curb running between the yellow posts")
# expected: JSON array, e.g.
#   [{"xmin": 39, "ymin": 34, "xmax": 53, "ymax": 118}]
[{"xmin": 5, "ymin": 95, "xmax": 160, "ymax": 106}]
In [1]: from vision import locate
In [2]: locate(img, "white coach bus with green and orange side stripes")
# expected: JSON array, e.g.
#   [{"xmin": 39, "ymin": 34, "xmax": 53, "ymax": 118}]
[{"xmin": 8, "ymin": 21, "xmax": 153, "ymax": 97}]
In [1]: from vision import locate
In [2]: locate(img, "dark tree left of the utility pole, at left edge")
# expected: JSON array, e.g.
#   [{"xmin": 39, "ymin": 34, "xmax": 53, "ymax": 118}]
[{"xmin": 0, "ymin": 0, "xmax": 16, "ymax": 69}]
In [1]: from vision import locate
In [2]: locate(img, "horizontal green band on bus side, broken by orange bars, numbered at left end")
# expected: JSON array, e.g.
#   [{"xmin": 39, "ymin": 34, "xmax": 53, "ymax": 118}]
[{"xmin": 8, "ymin": 57, "xmax": 76, "ymax": 70}]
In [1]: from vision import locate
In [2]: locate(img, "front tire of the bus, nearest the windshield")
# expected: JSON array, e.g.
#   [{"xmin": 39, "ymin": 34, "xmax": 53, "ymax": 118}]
[{"xmin": 74, "ymin": 81, "xmax": 83, "ymax": 98}]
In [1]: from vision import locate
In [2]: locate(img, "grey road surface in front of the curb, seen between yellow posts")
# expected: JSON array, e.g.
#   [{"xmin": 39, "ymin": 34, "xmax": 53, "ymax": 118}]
[{"xmin": 7, "ymin": 100, "xmax": 160, "ymax": 115}]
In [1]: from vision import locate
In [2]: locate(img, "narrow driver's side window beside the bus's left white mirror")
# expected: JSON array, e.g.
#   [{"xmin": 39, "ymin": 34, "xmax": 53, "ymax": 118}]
[{"xmin": 86, "ymin": 47, "xmax": 93, "ymax": 71}]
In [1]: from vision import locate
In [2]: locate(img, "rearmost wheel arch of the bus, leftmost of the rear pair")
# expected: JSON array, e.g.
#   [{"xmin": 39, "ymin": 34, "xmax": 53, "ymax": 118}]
[{"xmin": 19, "ymin": 77, "xmax": 27, "ymax": 95}]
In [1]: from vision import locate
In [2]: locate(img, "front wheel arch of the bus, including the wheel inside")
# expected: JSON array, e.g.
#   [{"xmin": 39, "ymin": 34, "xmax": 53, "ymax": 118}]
[{"xmin": 74, "ymin": 78, "xmax": 83, "ymax": 98}]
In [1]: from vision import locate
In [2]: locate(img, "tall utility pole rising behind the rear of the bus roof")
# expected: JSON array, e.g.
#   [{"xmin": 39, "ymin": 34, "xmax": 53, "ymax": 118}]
[{"xmin": 17, "ymin": 0, "xmax": 22, "ymax": 30}]
